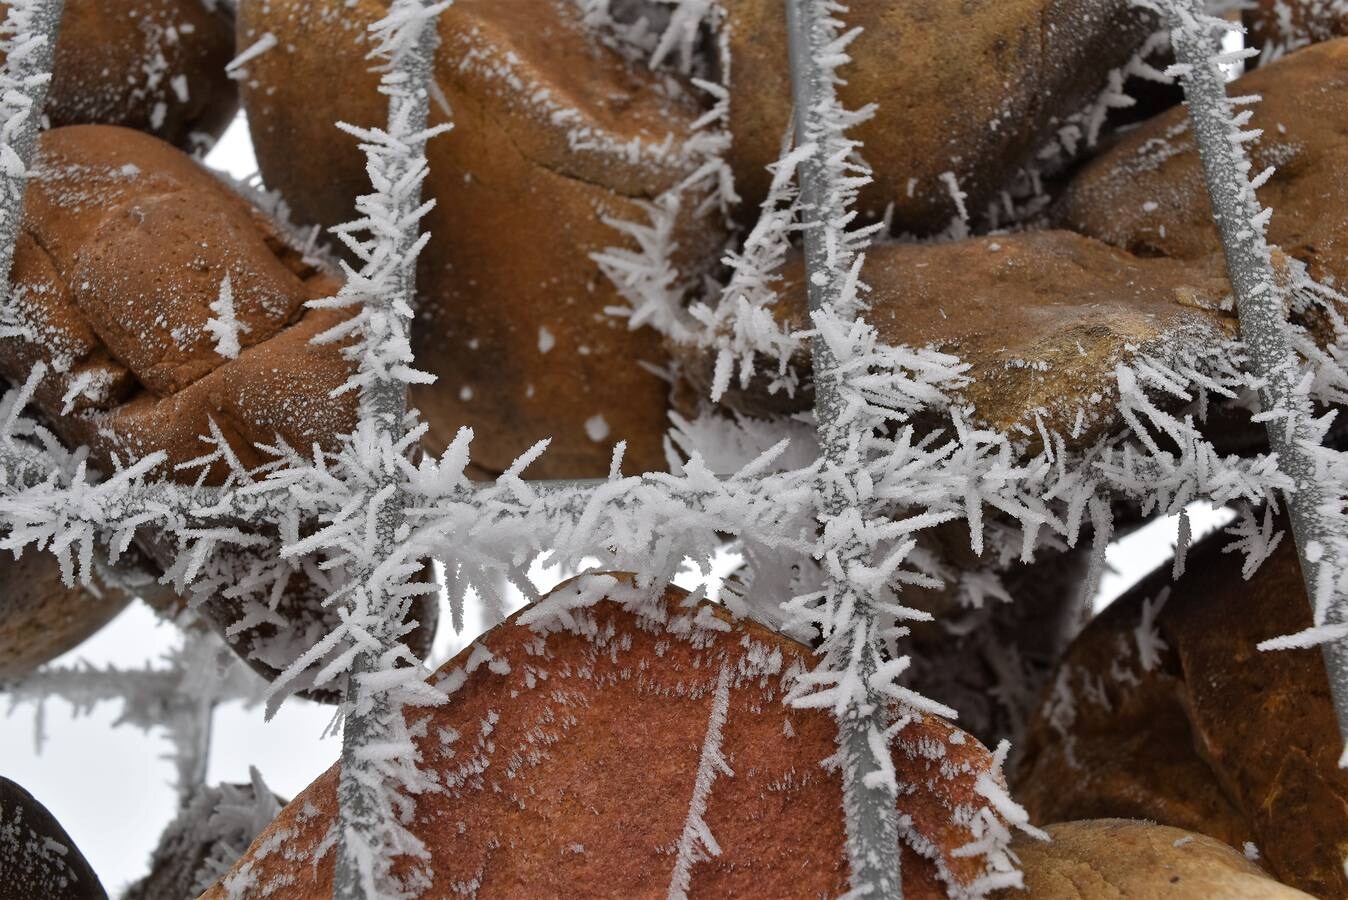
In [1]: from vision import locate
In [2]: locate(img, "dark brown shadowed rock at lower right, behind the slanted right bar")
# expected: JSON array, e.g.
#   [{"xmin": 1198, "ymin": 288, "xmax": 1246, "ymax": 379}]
[{"xmin": 1015, "ymin": 522, "xmax": 1348, "ymax": 897}]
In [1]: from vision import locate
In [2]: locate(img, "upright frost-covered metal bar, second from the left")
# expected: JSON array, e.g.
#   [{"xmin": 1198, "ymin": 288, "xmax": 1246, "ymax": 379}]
[{"xmin": 329, "ymin": 0, "xmax": 449, "ymax": 900}]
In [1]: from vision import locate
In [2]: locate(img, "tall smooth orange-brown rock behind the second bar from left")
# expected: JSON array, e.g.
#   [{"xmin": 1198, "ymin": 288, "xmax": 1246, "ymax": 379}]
[{"xmin": 240, "ymin": 0, "xmax": 720, "ymax": 477}]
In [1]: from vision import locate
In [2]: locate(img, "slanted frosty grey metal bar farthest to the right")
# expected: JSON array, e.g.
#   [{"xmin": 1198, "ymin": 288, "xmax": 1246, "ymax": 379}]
[{"xmin": 1148, "ymin": 0, "xmax": 1348, "ymax": 742}]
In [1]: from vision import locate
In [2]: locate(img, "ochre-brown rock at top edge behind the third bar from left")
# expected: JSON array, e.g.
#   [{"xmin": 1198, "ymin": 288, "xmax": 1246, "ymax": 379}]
[{"xmin": 725, "ymin": 0, "xmax": 1154, "ymax": 233}]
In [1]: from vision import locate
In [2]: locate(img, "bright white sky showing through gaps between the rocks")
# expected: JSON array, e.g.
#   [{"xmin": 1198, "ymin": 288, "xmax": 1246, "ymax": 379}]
[{"xmin": 0, "ymin": 117, "xmax": 1229, "ymax": 896}]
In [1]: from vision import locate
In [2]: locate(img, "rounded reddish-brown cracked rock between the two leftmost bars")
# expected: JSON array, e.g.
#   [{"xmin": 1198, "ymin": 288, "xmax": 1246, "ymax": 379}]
[{"xmin": 0, "ymin": 125, "xmax": 435, "ymax": 689}]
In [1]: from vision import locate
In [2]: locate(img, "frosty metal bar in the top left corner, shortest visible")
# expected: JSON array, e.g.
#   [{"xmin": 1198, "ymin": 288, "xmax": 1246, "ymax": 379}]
[{"xmin": 0, "ymin": 0, "xmax": 65, "ymax": 294}]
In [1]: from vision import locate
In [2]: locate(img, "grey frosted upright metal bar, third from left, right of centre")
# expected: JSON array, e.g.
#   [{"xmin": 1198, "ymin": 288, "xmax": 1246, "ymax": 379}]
[{"xmin": 786, "ymin": 0, "xmax": 903, "ymax": 899}]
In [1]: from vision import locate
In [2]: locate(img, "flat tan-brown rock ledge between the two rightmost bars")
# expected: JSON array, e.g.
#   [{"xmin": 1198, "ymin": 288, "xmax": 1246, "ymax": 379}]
[{"xmin": 682, "ymin": 230, "xmax": 1235, "ymax": 449}]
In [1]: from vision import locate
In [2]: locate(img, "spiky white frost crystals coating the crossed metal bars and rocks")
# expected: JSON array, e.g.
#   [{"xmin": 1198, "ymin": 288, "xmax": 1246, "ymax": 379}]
[{"xmin": 0, "ymin": 0, "xmax": 1348, "ymax": 896}]
